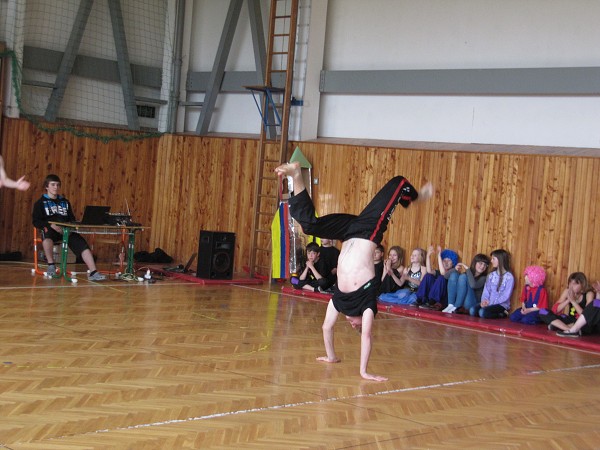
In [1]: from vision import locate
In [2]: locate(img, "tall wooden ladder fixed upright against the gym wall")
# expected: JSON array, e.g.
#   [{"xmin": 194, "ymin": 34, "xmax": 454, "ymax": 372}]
[{"xmin": 248, "ymin": 0, "xmax": 299, "ymax": 278}]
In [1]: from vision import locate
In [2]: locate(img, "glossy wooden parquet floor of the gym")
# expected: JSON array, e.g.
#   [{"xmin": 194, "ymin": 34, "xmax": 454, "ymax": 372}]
[{"xmin": 0, "ymin": 264, "xmax": 600, "ymax": 450}]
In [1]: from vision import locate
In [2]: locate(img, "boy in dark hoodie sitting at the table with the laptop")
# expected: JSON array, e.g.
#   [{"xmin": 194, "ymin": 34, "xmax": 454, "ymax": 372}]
[{"xmin": 31, "ymin": 174, "xmax": 106, "ymax": 281}]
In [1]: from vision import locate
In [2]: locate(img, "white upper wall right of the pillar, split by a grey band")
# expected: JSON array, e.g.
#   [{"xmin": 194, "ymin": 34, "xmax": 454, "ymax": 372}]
[{"xmin": 319, "ymin": 0, "xmax": 600, "ymax": 147}]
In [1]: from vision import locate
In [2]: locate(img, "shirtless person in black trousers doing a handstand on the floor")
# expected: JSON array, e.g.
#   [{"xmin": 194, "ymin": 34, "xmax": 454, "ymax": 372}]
[{"xmin": 275, "ymin": 162, "xmax": 433, "ymax": 381}]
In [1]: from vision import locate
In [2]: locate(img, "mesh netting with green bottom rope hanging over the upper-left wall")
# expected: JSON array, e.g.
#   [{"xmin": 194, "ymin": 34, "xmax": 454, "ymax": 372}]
[{"xmin": 0, "ymin": 0, "xmax": 172, "ymax": 142}]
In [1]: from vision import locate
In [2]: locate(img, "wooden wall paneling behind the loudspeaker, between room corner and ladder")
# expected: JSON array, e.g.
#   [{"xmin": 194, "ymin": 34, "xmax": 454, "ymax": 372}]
[{"xmin": 152, "ymin": 136, "xmax": 258, "ymax": 272}]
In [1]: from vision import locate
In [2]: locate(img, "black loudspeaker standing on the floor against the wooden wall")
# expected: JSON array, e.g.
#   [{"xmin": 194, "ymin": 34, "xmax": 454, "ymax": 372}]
[{"xmin": 196, "ymin": 230, "xmax": 235, "ymax": 280}]
